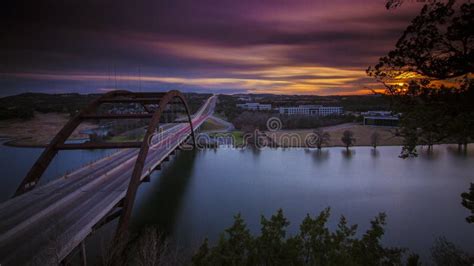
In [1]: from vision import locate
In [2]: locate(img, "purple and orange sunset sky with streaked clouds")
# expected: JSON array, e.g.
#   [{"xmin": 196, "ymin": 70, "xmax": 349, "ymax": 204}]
[{"xmin": 0, "ymin": 0, "xmax": 422, "ymax": 96}]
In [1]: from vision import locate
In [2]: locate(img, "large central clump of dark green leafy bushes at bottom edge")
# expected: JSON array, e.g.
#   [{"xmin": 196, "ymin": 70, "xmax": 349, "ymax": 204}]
[{"xmin": 192, "ymin": 208, "xmax": 404, "ymax": 265}]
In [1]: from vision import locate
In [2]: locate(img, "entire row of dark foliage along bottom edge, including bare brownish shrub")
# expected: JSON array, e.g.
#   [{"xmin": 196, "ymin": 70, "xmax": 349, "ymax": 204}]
[{"xmin": 100, "ymin": 208, "xmax": 474, "ymax": 266}]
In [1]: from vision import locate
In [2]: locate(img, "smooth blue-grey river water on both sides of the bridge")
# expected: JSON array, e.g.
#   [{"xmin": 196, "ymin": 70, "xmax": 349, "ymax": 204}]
[{"xmin": 0, "ymin": 142, "xmax": 474, "ymax": 258}]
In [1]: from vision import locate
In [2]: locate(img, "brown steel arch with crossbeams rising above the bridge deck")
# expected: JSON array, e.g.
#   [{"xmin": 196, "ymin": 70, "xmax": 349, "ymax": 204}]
[{"xmin": 14, "ymin": 90, "xmax": 196, "ymax": 196}]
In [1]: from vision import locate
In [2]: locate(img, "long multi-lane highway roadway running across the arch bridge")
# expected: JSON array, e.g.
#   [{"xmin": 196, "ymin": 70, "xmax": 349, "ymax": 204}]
[{"xmin": 0, "ymin": 96, "xmax": 216, "ymax": 266}]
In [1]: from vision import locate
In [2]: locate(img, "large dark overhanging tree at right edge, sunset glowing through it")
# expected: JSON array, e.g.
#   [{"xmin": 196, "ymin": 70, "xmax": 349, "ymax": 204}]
[{"xmin": 367, "ymin": 0, "xmax": 474, "ymax": 158}]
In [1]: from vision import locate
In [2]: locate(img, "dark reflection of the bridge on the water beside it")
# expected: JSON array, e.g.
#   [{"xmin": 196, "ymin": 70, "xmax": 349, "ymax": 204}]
[{"xmin": 132, "ymin": 151, "xmax": 197, "ymax": 234}]
